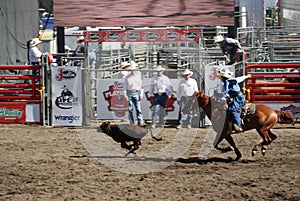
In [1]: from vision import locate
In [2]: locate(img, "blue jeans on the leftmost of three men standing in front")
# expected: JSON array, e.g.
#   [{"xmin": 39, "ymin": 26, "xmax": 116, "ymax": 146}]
[{"xmin": 127, "ymin": 92, "xmax": 143, "ymax": 125}]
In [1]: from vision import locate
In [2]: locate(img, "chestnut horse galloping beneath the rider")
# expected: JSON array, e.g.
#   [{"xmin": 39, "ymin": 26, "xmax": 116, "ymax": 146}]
[{"xmin": 183, "ymin": 92, "xmax": 295, "ymax": 160}]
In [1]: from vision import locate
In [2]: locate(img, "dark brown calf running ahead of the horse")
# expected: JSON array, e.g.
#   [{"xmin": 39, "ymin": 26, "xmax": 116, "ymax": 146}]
[{"xmin": 100, "ymin": 122, "xmax": 162, "ymax": 153}]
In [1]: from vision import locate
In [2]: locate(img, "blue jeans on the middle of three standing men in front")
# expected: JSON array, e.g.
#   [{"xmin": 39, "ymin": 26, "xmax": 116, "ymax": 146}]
[{"xmin": 152, "ymin": 93, "xmax": 167, "ymax": 124}]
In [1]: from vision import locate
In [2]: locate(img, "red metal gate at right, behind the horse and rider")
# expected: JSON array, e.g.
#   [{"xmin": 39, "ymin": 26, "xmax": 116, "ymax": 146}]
[{"xmin": 246, "ymin": 63, "xmax": 300, "ymax": 103}]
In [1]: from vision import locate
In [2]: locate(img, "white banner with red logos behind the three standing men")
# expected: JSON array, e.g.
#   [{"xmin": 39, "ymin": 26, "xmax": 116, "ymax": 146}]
[{"xmin": 97, "ymin": 79, "xmax": 179, "ymax": 120}]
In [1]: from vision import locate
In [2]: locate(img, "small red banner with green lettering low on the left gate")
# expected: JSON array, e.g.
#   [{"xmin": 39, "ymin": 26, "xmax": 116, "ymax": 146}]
[{"xmin": 0, "ymin": 102, "xmax": 26, "ymax": 123}]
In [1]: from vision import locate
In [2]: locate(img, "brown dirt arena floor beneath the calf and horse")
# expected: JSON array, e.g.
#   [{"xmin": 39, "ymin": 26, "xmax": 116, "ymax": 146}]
[{"xmin": 0, "ymin": 121, "xmax": 300, "ymax": 201}]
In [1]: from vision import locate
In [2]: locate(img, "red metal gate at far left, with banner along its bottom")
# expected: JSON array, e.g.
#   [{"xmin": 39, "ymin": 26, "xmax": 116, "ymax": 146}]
[{"xmin": 0, "ymin": 66, "xmax": 43, "ymax": 124}]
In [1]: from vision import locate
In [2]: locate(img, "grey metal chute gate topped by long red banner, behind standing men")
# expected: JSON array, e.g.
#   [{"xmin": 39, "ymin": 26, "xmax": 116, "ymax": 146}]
[{"xmin": 84, "ymin": 29, "xmax": 201, "ymax": 125}]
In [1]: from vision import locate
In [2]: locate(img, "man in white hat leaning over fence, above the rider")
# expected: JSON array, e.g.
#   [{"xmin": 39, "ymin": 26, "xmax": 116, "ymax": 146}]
[{"xmin": 214, "ymin": 35, "xmax": 242, "ymax": 65}]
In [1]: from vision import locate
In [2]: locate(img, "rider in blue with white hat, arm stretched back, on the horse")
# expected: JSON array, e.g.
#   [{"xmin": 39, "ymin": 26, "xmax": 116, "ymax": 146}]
[{"xmin": 217, "ymin": 68, "xmax": 251, "ymax": 133}]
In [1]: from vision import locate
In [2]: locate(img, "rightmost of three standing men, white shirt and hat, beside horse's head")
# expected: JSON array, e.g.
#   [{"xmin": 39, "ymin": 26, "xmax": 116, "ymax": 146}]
[{"xmin": 177, "ymin": 69, "xmax": 198, "ymax": 129}]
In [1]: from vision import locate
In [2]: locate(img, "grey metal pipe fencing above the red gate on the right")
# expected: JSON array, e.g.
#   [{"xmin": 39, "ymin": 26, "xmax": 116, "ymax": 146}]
[{"xmin": 237, "ymin": 27, "xmax": 300, "ymax": 62}]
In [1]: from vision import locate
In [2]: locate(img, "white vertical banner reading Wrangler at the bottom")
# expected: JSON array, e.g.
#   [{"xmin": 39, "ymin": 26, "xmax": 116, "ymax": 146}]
[{"xmin": 51, "ymin": 66, "xmax": 83, "ymax": 126}]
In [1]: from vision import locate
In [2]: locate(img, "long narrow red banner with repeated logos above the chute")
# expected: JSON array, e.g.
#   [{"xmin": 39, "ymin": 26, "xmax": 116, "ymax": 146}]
[{"xmin": 84, "ymin": 29, "xmax": 200, "ymax": 43}]
